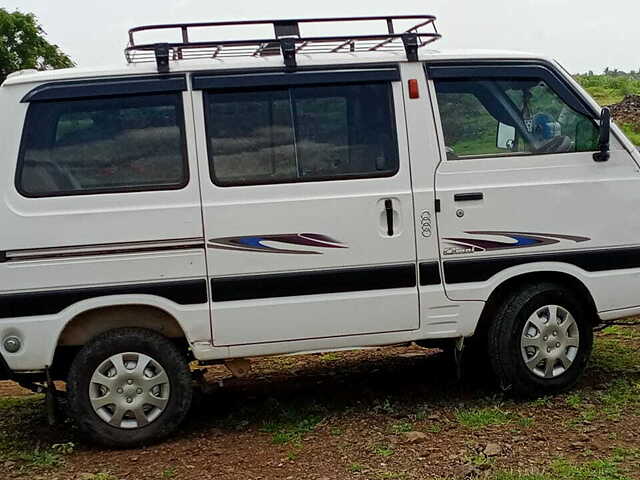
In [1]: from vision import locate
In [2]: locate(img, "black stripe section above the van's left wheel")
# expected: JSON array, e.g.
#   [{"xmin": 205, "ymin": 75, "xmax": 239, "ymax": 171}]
[{"xmin": 0, "ymin": 279, "xmax": 207, "ymax": 318}]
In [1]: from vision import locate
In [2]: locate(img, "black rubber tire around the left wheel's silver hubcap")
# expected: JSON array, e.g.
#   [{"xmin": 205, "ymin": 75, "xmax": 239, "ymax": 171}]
[{"xmin": 67, "ymin": 328, "xmax": 192, "ymax": 448}]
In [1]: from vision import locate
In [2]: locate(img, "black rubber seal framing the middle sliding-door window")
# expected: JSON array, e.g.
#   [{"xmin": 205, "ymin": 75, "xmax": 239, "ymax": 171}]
[{"xmin": 202, "ymin": 79, "xmax": 401, "ymax": 188}]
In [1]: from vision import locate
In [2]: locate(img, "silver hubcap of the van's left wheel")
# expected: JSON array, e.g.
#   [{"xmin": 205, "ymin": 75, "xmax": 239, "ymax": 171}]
[{"xmin": 89, "ymin": 352, "xmax": 170, "ymax": 429}]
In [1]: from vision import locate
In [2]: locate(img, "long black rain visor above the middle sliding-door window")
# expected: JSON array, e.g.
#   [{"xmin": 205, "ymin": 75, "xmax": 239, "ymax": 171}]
[{"xmin": 192, "ymin": 66, "xmax": 401, "ymax": 90}]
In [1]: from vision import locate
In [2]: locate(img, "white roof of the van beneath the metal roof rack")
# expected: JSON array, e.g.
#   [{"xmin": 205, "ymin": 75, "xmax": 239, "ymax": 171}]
[{"xmin": 2, "ymin": 50, "xmax": 550, "ymax": 86}]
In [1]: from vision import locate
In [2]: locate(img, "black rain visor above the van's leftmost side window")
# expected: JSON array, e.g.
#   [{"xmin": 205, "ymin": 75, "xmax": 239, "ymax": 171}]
[{"xmin": 21, "ymin": 75, "xmax": 188, "ymax": 103}]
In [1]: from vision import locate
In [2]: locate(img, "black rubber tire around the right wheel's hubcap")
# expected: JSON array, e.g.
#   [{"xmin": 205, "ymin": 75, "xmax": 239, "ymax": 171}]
[{"xmin": 488, "ymin": 282, "xmax": 593, "ymax": 398}]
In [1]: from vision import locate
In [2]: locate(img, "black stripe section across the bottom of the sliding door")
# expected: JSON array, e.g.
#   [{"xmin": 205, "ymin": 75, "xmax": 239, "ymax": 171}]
[{"xmin": 211, "ymin": 264, "xmax": 416, "ymax": 302}]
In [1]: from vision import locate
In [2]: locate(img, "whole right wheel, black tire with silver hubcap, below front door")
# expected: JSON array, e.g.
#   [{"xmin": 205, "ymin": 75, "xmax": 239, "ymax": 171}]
[{"xmin": 488, "ymin": 282, "xmax": 593, "ymax": 397}]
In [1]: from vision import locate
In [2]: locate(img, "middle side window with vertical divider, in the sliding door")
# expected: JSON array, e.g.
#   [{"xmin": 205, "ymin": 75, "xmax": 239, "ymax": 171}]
[{"xmin": 206, "ymin": 83, "xmax": 398, "ymax": 186}]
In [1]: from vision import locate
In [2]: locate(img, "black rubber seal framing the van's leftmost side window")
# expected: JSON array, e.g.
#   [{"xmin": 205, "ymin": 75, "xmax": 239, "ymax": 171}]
[{"xmin": 14, "ymin": 92, "xmax": 191, "ymax": 199}]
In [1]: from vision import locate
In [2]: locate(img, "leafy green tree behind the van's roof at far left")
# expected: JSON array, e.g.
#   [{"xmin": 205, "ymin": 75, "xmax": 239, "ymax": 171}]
[{"xmin": 0, "ymin": 8, "xmax": 74, "ymax": 83}]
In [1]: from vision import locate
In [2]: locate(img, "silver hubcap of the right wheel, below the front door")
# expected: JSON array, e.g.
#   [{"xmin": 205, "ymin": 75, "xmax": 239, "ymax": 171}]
[{"xmin": 520, "ymin": 305, "xmax": 580, "ymax": 378}]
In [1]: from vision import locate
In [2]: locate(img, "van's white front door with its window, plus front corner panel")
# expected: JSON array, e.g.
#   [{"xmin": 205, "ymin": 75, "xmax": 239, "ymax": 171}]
[{"xmin": 429, "ymin": 65, "xmax": 640, "ymax": 310}]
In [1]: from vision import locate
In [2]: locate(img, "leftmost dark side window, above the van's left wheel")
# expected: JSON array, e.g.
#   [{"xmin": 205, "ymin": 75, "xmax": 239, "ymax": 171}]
[{"xmin": 16, "ymin": 94, "xmax": 189, "ymax": 197}]
